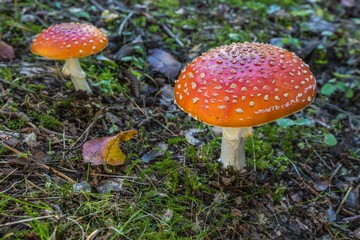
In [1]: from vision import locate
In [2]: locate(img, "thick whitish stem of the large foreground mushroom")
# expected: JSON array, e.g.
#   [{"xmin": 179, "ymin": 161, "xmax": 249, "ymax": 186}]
[{"xmin": 220, "ymin": 127, "xmax": 252, "ymax": 170}]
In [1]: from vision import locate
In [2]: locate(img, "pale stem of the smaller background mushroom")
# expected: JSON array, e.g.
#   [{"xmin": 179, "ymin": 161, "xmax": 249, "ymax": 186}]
[{"xmin": 62, "ymin": 58, "xmax": 91, "ymax": 93}]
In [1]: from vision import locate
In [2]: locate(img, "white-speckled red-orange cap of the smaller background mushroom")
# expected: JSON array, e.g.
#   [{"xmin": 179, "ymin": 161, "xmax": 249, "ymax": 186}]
[{"xmin": 31, "ymin": 22, "xmax": 108, "ymax": 60}]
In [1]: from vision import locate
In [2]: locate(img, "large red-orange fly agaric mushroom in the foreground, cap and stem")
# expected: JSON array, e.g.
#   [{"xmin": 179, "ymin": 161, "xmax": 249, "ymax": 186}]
[{"xmin": 174, "ymin": 42, "xmax": 316, "ymax": 170}]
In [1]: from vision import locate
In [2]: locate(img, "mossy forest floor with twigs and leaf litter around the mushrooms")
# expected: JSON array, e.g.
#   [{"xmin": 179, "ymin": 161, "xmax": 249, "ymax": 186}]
[{"xmin": 0, "ymin": 0, "xmax": 360, "ymax": 240}]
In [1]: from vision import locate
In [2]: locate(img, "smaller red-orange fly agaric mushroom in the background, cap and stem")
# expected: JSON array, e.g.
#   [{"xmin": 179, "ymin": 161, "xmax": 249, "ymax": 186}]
[{"xmin": 31, "ymin": 22, "xmax": 108, "ymax": 92}]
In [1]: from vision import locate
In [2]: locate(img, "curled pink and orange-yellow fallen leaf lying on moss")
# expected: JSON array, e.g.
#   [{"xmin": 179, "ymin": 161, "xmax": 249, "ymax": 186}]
[{"xmin": 82, "ymin": 130, "xmax": 137, "ymax": 166}]
